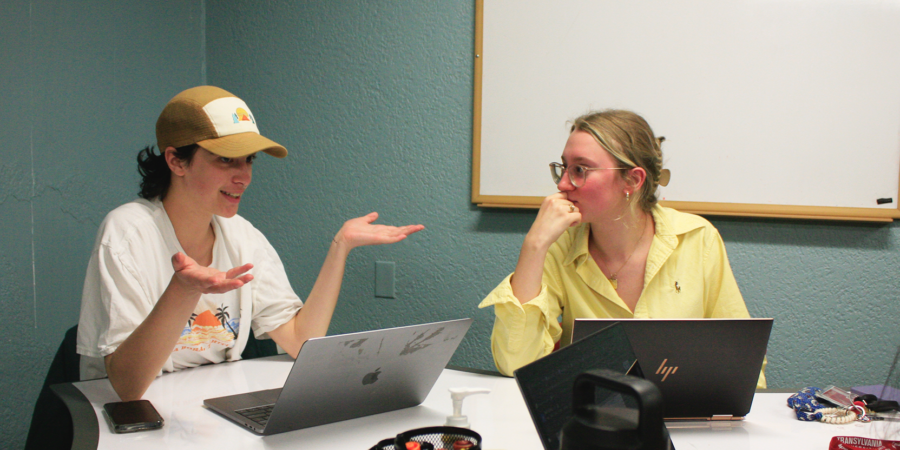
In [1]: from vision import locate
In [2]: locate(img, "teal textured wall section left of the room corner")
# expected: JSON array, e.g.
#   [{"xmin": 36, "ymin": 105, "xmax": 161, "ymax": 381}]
[{"xmin": 0, "ymin": 0, "xmax": 205, "ymax": 448}]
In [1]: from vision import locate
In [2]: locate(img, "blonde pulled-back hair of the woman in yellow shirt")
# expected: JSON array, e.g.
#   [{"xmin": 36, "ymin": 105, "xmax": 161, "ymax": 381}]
[{"xmin": 570, "ymin": 109, "xmax": 669, "ymax": 212}]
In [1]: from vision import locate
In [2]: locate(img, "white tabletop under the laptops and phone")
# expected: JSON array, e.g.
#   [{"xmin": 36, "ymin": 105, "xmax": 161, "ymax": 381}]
[{"xmin": 59, "ymin": 356, "xmax": 900, "ymax": 450}]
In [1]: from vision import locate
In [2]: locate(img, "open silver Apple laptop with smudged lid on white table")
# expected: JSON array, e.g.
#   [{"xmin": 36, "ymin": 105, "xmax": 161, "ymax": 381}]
[{"xmin": 203, "ymin": 319, "xmax": 472, "ymax": 435}]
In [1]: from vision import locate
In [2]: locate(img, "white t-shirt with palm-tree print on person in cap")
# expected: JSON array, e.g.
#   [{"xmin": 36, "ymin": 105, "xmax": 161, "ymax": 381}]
[{"xmin": 77, "ymin": 199, "xmax": 303, "ymax": 380}]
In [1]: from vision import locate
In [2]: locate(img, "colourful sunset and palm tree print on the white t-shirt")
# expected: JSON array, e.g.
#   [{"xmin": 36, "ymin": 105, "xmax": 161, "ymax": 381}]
[{"xmin": 174, "ymin": 301, "xmax": 240, "ymax": 352}]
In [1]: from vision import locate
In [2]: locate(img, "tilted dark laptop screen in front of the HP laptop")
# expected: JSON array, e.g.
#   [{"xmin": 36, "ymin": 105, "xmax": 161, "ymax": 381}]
[{"xmin": 514, "ymin": 324, "xmax": 636, "ymax": 450}]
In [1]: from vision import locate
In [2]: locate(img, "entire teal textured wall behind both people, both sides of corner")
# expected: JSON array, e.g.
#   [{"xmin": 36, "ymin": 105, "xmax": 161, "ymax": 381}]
[{"xmin": 0, "ymin": 0, "xmax": 900, "ymax": 448}]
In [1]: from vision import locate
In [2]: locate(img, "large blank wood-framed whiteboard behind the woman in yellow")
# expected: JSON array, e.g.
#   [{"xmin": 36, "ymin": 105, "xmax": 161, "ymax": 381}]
[{"xmin": 472, "ymin": 0, "xmax": 900, "ymax": 220}]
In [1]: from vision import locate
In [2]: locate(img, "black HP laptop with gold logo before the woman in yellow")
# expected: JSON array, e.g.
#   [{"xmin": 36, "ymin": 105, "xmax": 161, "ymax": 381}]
[{"xmin": 572, "ymin": 319, "xmax": 773, "ymax": 420}]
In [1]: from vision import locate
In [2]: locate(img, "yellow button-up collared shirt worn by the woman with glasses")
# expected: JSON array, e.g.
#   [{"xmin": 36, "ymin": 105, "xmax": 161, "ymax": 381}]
[{"xmin": 478, "ymin": 206, "xmax": 765, "ymax": 388}]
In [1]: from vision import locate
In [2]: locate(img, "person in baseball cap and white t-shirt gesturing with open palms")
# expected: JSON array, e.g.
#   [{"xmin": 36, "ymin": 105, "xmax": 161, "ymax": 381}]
[{"xmin": 77, "ymin": 86, "xmax": 424, "ymax": 401}]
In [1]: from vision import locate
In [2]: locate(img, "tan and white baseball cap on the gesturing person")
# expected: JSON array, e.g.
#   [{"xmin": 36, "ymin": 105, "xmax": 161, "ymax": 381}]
[{"xmin": 156, "ymin": 86, "xmax": 287, "ymax": 158}]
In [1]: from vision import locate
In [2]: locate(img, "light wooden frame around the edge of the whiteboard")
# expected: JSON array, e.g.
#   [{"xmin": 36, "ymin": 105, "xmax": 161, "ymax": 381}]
[{"xmin": 472, "ymin": 0, "xmax": 900, "ymax": 222}]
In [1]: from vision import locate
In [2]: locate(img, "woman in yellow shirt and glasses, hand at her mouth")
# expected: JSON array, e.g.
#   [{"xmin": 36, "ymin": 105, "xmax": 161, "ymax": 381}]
[{"xmin": 479, "ymin": 110, "xmax": 765, "ymax": 387}]
